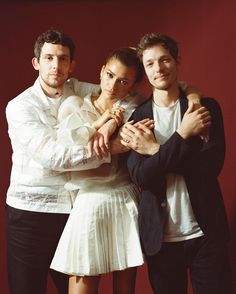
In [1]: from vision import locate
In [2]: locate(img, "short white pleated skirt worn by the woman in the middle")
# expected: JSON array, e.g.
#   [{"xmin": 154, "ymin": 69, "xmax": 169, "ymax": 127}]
[{"xmin": 51, "ymin": 184, "xmax": 144, "ymax": 276}]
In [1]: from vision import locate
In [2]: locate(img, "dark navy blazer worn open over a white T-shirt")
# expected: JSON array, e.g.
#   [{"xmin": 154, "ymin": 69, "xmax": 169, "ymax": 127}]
[{"xmin": 127, "ymin": 94, "xmax": 229, "ymax": 255}]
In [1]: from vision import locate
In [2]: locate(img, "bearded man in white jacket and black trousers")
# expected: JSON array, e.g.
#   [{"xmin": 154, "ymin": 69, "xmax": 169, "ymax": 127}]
[{"xmin": 6, "ymin": 30, "xmax": 110, "ymax": 294}]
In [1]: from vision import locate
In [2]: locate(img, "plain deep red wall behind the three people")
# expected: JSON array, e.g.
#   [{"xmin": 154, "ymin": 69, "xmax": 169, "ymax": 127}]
[{"xmin": 0, "ymin": 0, "xmax": 236, "ymax": 294}]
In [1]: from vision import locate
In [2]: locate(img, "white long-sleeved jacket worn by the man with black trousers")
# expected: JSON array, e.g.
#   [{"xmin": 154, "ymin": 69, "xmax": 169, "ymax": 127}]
[{"xmin": 6, "ymin": 78, "xmax": 110, "ymax": 213}]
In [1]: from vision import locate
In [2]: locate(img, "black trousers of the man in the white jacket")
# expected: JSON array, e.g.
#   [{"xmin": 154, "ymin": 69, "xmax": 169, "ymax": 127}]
[{"xmin": 6, "ymin": 206, "xmax": 68, "ymax": 294}]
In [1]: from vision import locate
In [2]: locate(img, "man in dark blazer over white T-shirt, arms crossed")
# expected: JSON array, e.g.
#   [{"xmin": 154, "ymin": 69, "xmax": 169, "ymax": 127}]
[{"xmin": 121, "ymin": 34, "xmax": 231, "ymax": 294}]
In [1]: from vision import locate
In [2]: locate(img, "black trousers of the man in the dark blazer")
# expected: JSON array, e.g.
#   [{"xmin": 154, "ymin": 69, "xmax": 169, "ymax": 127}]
[{"xmin": 146, "ymin": 236, "xmax": 233, "ymax": 294}]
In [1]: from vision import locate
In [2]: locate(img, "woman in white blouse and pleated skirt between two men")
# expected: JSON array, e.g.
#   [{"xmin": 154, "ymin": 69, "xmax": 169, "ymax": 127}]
[{"xmin": 51, "ymin": 48, "xmax": 148, "ymax": 294}]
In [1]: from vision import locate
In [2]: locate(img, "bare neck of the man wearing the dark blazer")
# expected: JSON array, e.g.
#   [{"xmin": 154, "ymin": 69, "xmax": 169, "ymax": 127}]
[{"xmin": 153, "ymin": 84, "xmax": 179, "ymax": 107}]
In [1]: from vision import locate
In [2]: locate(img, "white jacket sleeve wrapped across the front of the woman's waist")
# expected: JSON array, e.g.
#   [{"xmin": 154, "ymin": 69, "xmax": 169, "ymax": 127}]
[{"xmin": 6, "ymin": 102, "xmax": 110, "ymax": 171}]
